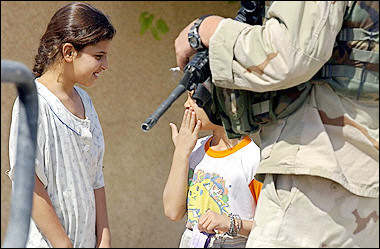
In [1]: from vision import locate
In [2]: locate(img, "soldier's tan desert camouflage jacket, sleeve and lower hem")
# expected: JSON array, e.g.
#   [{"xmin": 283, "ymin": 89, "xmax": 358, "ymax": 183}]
[{"xmin": 209, "ymin": 1, "xmax": 379, "ymax": 198}]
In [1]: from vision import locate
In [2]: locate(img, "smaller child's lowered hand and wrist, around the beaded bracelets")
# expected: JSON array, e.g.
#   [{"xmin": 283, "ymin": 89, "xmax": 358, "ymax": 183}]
[{"xmin": 198, "ymin": 210, "xmax": 253, "ymax": 237}]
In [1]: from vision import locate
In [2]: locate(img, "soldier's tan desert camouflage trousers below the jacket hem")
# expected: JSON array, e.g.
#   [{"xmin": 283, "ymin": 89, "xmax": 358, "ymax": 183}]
[{"xmin": 246, "ymin": 175, "xmax": 379, "ymax": 248}]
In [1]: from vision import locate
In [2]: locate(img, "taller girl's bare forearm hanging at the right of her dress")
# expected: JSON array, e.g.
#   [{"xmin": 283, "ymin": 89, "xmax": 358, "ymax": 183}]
[{"xmin": 94, "ymin": 187, "xmax": 111, "ymax": 248}]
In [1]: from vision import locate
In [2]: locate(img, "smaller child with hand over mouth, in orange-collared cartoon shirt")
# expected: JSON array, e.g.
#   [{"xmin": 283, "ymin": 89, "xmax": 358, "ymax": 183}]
[{"xmin": 163, "ymin": 88, "xmax": 261, "ymax": 248}]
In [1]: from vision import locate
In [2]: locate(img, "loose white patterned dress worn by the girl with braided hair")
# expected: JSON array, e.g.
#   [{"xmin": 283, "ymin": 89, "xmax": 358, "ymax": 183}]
[{"xmin": 9, "ymin": 79, "xmax": 104, "ymax": 248}]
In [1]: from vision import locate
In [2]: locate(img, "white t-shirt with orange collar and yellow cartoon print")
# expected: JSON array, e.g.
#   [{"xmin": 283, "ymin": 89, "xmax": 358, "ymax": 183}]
[{"xmin": 186, "ymin": 136, "xmax": 260, "ymax": 231}]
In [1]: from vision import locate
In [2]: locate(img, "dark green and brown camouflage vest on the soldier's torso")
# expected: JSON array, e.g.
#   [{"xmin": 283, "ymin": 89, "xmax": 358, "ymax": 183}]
[{"xmin": 314, "ymin": 1, "xmax": 379, "ymax": 101}]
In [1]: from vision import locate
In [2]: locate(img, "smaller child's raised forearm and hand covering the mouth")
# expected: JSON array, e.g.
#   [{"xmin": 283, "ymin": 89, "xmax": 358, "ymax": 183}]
[{"xmin": 163, "ymin": 108, "xmax": 201, "ymax": 221}]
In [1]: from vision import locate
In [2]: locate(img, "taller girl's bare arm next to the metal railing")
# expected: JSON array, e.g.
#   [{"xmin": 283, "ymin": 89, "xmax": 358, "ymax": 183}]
[{"xmin": 32, "ymin": 175, "xmax": 73, "ymax": 248}]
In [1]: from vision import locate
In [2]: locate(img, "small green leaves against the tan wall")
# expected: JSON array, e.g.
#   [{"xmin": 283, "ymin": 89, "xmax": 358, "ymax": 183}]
[{"xmin": 139, "ymin": 11, "xmax": 169, "ymax": 40}]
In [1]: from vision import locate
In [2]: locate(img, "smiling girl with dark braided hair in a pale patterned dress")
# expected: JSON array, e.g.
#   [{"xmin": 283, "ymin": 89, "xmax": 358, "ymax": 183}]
[{"xmin": 9, "ymin": 2, "xmax": 116, "ymax": 248}]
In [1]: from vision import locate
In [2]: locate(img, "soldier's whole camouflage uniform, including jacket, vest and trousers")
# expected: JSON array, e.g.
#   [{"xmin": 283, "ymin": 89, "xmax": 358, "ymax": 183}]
[{"xmin": 209, "ymin": 1, "xmax": 379, "ymax": 247}]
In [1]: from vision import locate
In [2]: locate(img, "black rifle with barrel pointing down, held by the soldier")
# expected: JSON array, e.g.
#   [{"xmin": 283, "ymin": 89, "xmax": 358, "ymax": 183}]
[{"xmin": 141, "ymin": 1, "xmax": 265, "ymax": 132}]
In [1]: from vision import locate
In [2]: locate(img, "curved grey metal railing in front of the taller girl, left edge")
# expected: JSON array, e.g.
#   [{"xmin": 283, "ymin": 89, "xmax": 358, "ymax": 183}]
[{"xmin": 1, "ymin": 60, "xmax": 38, "ymax": 248}]
